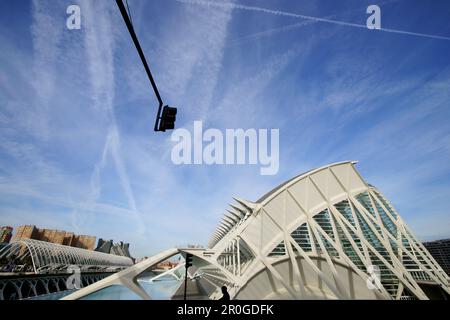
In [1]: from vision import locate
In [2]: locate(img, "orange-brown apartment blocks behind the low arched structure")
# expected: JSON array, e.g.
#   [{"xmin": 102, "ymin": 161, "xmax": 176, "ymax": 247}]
[{"xmin": 12, "ymin": 225, "xmax": 96, "ymax": 250}]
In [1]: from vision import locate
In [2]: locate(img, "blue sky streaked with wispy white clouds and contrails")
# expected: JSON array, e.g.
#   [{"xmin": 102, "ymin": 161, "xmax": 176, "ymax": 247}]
[{"xmin": 0, "ymin": 0, "xmax": 450, "ymax": 256}]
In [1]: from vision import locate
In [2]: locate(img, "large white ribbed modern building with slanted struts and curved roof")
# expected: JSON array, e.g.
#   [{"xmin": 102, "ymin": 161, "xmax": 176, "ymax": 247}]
[{"xmin": 66, "ymin": 161, "xmax": 450, "ymax": 300}]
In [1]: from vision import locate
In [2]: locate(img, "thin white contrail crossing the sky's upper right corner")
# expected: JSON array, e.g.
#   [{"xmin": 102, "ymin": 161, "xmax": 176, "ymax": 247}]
[{"xmin": 176, "ymin": 0, "xmax": 450, "ymax": 41}]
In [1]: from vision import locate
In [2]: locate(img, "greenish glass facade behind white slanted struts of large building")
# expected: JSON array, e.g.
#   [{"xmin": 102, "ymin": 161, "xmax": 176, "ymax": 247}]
[{"xmin": 269, "ymin": 188, "xmax": 446, "ymax": 299}]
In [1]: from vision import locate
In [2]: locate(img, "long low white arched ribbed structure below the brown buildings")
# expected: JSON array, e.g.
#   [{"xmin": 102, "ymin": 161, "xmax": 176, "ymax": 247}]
[{"xmin": 0, "ymin": 239, "xmax": 133, "ymax": 274}]
